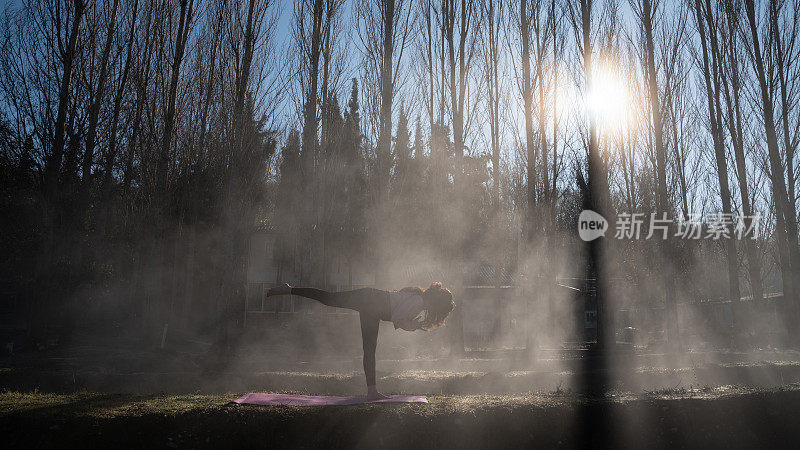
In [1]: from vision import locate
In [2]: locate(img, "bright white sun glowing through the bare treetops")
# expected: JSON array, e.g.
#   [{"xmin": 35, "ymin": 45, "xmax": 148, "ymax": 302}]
[{"xmin": 584, "ymin": 64, "xmax": 630, "ymax": 133}]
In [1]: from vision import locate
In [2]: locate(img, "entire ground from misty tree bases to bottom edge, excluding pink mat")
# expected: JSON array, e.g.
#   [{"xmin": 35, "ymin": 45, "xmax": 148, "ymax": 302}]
[{"xmin": 0, "ymin": 343, "xmax": 800, "ymax": 448}]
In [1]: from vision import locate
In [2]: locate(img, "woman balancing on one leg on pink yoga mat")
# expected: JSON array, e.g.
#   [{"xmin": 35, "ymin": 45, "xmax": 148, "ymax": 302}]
[{"xmin": 267, "ymin": 281, "xmax": 456, "ymax": 400}]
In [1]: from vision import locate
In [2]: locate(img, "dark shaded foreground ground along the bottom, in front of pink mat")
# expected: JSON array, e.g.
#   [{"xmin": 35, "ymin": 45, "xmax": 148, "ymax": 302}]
[{"xmin": 0, "ymin": 385, "xmax": 800, "ymax": 448}]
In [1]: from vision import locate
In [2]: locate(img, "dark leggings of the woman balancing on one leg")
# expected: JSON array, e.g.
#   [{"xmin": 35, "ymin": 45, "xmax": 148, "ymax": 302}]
[{"xmin": 292, "ymin": 288, "xmax": 391, "ymax": 386}]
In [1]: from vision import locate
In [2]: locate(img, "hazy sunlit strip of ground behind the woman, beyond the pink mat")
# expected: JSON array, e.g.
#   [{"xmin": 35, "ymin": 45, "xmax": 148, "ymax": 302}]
[{"xmin": 0, "ymin": 330, "xmax": 800, "ymax": 395}]
